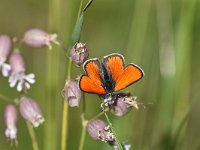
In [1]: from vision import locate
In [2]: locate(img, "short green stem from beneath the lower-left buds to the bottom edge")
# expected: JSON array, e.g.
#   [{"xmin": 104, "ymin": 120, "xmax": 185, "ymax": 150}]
[{"xmin": 26, "ymin": 121, "xmax": 39, "ymax": 150}]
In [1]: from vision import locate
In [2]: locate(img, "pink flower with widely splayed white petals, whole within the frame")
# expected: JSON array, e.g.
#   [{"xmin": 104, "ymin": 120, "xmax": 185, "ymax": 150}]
[{"xmin": 8, "ymin": 52, "xmax": 35, "ymax": 92}]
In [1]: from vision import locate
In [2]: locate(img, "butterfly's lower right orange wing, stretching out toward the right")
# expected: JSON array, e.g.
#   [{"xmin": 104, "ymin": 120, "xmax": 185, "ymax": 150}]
[{"xmin": 114, "ymin": 64, "xmax": 144, "ymax": 92}]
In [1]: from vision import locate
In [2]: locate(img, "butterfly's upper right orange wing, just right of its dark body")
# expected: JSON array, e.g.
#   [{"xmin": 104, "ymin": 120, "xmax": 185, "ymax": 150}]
[{"xmin": 103, "ymin": 53, "xmax": 125, "ymax": 82}]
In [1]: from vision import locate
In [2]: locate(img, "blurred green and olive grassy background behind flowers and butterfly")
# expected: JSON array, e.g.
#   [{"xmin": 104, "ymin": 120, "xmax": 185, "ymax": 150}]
[{"xmin": 0, "ymin": 0, "xmax": 200, "ymax": 150}]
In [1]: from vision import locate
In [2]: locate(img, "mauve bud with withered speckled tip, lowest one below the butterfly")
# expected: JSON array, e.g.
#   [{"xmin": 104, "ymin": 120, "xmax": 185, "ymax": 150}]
[{"xmin": 87, "ymin": 119, "xmax": 115, "ymax": 143}]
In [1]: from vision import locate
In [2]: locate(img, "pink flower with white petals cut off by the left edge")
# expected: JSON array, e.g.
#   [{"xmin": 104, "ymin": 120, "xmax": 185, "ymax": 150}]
[{"xmin": 0, "ymin": 35, "xmax": 12, "ymax": 77}]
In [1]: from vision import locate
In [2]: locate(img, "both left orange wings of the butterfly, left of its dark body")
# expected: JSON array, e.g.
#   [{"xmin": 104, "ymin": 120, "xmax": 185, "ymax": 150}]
[{"xmin": 79, "ymin": 59, "xmax": 106, "ymax": 95}]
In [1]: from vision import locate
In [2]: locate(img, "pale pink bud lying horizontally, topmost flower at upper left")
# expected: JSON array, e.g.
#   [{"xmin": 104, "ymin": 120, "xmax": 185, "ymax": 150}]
[{"xmin": 24, "ymin": 28, "xmax": 59, "ymax": 49}]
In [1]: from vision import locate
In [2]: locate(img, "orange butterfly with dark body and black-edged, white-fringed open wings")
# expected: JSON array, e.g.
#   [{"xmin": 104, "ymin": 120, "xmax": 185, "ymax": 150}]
[{"xmin": 79, "ymin": 53, "xmax": 144, "ymax": 98}]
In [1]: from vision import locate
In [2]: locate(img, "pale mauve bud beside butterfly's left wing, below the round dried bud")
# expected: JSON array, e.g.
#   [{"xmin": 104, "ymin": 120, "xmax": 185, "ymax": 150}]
[{"xmin": 62, "ymin": 80, "xmax": 81, "ymax": 107}]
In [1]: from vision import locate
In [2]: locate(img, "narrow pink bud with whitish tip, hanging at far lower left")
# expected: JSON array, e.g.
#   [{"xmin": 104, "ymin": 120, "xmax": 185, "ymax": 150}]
[{"xmin": 4, "ymin": 104, "xmax": 17, "ymax": 140}]
